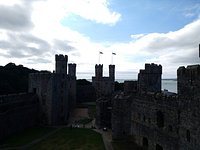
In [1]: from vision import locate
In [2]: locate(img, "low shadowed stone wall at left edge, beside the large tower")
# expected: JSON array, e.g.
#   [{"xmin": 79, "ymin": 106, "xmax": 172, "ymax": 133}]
[{"xmin": 0, "ymin": 93, "xmax": 39, "ymax": 140}]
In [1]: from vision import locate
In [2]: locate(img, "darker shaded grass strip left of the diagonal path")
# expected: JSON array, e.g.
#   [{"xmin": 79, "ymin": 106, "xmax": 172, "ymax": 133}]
[{"xmin": 0, "ymin": 127, "xmax": 55, "ymax": 147}]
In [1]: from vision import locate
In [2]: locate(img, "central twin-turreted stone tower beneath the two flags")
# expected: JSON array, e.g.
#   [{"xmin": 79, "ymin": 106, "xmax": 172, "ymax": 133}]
[{"xmin": 92, "ymin": 64, "xmax": 115, "ymax": 127}]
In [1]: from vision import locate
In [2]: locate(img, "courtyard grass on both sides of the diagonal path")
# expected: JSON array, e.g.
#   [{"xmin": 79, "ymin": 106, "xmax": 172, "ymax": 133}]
[{"xmin": 0, "ymin": 127, "xmax": 105, "ymax": 150}]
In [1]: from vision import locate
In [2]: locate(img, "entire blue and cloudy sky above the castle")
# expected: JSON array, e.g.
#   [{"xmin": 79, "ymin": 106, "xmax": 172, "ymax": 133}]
[{"xmin": 0, "ymin": 0, "xmax": 200, "ymax": 79}]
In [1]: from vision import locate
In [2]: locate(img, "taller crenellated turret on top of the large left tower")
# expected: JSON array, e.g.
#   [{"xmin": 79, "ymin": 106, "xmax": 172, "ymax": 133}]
[{"xmin": 55, "ymin": 55, "xmax": 68, "ymax": 74}]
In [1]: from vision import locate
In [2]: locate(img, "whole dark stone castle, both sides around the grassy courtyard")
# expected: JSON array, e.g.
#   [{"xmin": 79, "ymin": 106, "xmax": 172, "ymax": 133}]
[{"xmin": 0, "ymin": 51, "xmax": 200, "ymax": 150}]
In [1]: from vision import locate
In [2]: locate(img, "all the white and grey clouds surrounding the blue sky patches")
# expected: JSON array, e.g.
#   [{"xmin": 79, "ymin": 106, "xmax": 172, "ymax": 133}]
[{"xmin": 0, "ymin": 0, "xmax": 200, "ymax": 78}]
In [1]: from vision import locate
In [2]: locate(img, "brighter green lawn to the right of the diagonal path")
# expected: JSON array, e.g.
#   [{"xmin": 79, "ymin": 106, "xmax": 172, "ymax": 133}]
[{"xmin": 29, "ymin": 128, "xmax": 105, "ymax": 150}]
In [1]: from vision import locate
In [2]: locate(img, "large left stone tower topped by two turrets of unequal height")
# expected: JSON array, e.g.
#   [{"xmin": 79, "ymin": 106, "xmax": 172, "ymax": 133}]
[{"xmin": 29, "ymin": 55, "xmax": 76, "ymax": 125}]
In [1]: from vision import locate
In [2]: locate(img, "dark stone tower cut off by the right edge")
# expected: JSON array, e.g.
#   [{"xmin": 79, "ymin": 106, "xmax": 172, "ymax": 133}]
[{"xmin": 177, "ymin": 65, "xmax": 200, "ymax": 150}]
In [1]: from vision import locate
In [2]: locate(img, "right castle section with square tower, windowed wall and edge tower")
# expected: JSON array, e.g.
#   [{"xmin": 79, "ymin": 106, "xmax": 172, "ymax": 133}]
[{"xmin": 111, "ymin": 64, "xmax": 200, "ymax": 150}]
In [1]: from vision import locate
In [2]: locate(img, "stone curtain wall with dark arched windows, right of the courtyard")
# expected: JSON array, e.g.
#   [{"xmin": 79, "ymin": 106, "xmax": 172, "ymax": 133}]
[{"xmin": 131, "ymin": 94, "xmax": 179, "ymax": 150}]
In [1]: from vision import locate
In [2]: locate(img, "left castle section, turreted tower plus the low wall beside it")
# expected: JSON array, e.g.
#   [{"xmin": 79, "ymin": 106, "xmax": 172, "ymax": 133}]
[{"xmin": 0, "ymin": 55, "xmax": 76, "ymax": 140}]
